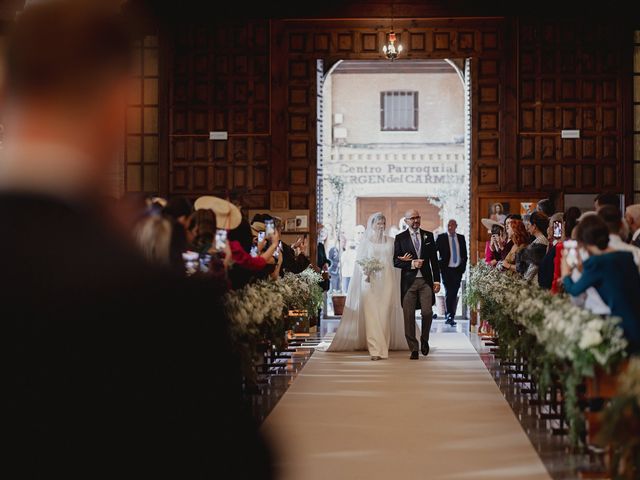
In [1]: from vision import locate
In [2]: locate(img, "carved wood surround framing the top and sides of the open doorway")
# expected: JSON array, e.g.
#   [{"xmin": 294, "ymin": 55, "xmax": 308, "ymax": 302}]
[{"xmin": 272, "ymin": 19, "xmax": 504, "ymax": 258}]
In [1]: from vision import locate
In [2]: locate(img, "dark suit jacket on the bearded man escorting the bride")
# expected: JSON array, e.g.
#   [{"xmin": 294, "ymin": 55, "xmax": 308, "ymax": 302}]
[{"xmin": 393, "ymin": 229, "xmax": 440, "ymax": 305}]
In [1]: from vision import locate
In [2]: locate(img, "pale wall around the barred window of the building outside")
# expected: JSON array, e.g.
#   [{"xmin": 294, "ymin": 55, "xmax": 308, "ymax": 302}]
[{"xmin": 327, "ymin": 72, "xmax": 464, "ymax": 144}]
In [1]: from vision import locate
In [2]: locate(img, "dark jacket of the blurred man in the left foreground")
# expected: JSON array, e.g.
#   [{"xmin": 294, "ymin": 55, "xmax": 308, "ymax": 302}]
[{"xmin": 0, "ymin": 193, "xmax": 269, "ymax": 479}]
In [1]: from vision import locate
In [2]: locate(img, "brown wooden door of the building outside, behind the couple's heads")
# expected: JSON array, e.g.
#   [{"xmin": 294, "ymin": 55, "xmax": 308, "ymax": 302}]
[{"xmin": 356, "ymin": 197, "xmax": 441, "ymax": 231}]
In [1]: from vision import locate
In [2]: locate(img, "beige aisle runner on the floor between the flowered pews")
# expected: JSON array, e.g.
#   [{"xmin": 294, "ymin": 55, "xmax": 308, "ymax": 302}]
[{"xmin": 264, "ymin": 333, "xmax": 550, "ymax": 480}]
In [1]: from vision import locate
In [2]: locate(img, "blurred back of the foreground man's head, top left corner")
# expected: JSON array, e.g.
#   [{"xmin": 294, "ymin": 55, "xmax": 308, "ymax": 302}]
[{"xmin": 4, "ymin": 0, "xmax": 131, "ymax": 105}]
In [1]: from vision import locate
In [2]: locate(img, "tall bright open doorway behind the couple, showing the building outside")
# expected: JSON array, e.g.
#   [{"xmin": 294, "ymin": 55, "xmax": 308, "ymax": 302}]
[{"xmin": 316, "ymin": 59, "xmax": 471, "ymax": 322}]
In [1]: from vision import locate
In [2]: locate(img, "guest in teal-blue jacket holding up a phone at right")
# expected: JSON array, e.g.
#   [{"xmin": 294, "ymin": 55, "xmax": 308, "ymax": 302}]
[{"xmin": 562, "ymin": 215, "xmax": 640, "ymax": 353}]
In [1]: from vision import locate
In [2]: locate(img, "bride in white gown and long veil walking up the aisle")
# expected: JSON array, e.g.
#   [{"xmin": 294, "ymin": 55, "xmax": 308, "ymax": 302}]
[{"xmin": 318, "ymin": 213, "xmax": 417, "ymax": 360}]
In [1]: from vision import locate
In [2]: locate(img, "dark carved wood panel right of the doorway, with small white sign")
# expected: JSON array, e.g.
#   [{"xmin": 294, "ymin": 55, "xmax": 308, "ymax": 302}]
[{"xmin": 517, "ymin": 18, "xmax": 628, "ymax": 192}]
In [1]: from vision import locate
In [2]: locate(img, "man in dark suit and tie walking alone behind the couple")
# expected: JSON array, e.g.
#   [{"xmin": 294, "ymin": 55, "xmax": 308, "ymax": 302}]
[{"xmin": 436, "ymin": 220, "xmax": 467, "ymax": 326}]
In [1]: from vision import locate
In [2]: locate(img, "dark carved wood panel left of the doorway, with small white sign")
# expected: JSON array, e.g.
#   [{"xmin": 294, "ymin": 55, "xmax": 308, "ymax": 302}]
[{"xmin": 169, "ymin": 20, "xmax": 271, "ymax": 208}]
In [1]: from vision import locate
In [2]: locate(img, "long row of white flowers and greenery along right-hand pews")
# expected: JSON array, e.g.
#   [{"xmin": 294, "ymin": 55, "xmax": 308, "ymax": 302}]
[{"xmin": 465, "ymin": 263, "xmax": 627, "ymax": 442}]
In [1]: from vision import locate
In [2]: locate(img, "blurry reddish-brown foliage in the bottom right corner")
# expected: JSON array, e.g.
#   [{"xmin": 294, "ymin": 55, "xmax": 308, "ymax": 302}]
[{"xmin": 598, "ymin": 357, "xmax": 640, "ymax": 480}]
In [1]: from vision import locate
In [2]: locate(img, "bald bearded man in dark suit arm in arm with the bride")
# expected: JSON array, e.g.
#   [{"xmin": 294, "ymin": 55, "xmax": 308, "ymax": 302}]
[{"xmin": 393, "ymin": 210, "xmax": 440, "ymax": 360}]
